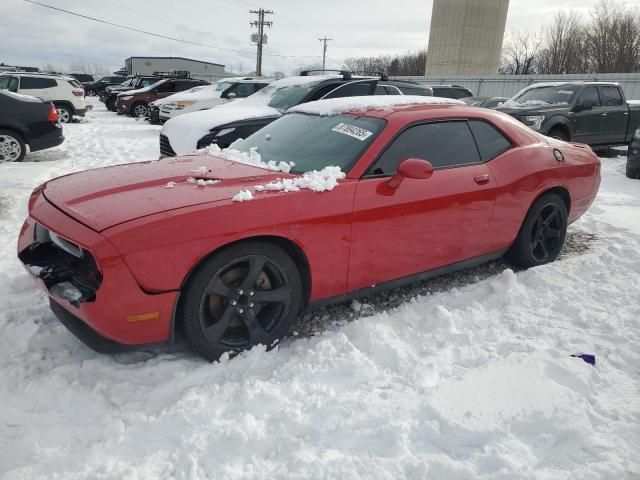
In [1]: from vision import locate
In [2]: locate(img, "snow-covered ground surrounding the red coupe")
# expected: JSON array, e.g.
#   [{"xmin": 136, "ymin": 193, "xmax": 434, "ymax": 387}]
[{"xmin": 0, "ymin": 99, "xmax": 640, "ymax": 480}]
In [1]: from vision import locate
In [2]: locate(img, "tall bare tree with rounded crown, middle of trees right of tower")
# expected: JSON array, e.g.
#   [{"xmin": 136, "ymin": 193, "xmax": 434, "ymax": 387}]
[{"xmin": 535, "ymin": 12, "xmax": 588, "ymax": 74}]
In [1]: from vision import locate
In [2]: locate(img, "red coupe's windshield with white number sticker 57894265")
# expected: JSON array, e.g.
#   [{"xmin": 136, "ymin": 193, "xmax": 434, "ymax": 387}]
[{"xmin": 231, "ymin": 113, "xmax": 386, "ymax": 173}]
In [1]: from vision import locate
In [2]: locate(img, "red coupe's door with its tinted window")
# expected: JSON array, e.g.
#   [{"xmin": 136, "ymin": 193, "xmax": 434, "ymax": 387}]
[{"xmin": 349, "ymin": 120, "xmax": 497, "ymax": 290}]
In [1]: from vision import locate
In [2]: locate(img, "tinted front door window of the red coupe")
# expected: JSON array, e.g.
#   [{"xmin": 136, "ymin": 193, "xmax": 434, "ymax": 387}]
[{"xmin": 367, "ymin": 121, "xmax": 480, "ymax": 175}]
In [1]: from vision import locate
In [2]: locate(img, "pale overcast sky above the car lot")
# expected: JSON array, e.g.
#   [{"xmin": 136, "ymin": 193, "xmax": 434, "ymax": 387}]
[{"xmin": 0, "ymin": 0, "xmax": 620, "ymax": 74}]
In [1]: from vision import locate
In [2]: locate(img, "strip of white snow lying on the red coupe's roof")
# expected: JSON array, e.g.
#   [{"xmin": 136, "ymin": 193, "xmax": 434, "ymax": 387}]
[{"xmin": 288, "ymin": 95, "xmax": 466, "ymax": 116}]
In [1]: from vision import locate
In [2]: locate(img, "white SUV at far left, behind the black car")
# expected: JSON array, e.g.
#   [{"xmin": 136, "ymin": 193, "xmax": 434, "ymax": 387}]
[{"xmin": 0, "ymin": 72, "xmax": 87, "ymax": 123}]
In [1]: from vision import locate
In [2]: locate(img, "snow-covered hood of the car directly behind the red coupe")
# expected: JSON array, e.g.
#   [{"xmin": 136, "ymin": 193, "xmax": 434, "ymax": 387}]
[{"xmin": 162, "ymin": 102, "xmax": 282, "ymax": 155}]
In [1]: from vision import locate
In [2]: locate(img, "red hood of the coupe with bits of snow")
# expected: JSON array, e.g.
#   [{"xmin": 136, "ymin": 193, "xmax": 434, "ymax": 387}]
[{"xmin": 43, "ymin": 155, "xmax": 294, "ymax": 232}]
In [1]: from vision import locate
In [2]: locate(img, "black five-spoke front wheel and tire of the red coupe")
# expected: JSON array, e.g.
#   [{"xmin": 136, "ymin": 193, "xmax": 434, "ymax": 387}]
[{"xmin": 181, "ymin": 241, "xmax": 303, "ymax": 361}]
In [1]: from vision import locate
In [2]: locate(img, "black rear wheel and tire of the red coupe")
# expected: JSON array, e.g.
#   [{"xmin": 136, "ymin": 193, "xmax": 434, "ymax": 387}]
[{"xmin": 507, "ymin": 193, "xmax": 568, "ymax": 268}]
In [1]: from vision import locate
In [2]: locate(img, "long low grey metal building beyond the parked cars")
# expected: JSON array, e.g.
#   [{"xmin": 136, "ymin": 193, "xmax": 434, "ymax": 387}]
[{"xmin": 124, "ymin": 57, "xmax": 225, "ymax": 81}]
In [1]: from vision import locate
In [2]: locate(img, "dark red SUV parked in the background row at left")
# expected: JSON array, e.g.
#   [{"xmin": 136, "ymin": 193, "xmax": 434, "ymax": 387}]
[{"xmin": 116, "ymin": 78, "xmax": 210, "ymax": 117}]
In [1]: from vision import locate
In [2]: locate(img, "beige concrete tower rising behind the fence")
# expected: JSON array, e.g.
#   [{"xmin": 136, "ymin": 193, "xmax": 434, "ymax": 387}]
[{"xmin": 425, "ymin": 0, "xmax": 509, "ymax": 75}]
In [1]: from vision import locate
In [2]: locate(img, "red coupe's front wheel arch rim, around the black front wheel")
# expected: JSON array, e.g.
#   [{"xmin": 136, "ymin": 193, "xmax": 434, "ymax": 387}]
[{"xmin": 171, "ymin": 235, "xmax": 311, "ymax": 341}]
